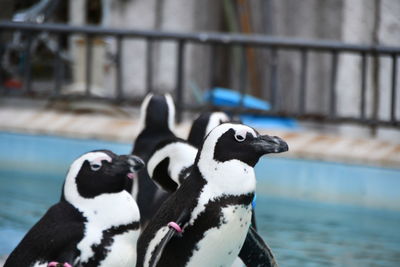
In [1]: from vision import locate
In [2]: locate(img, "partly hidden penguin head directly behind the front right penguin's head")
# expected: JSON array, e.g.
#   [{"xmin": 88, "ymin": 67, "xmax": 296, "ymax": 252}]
[{"xmin": 188, "ymin": 111, "xmax": 230, "ymax": 148}]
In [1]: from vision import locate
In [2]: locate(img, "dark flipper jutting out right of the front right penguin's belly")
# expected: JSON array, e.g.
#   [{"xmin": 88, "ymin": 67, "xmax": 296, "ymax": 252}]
[{"xmin": 239, "ymin": 226, "xmax": 278, "ymax": 267}]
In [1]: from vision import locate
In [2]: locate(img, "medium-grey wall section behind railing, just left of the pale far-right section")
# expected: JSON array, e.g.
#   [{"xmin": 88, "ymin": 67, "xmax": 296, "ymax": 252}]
[{"xmin": 267, "ymin": 0, "xmax": 343, "ymax": 112}]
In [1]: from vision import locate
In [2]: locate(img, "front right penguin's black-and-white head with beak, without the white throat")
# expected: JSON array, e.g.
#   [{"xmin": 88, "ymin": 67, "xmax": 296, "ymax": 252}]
[{"xmin": 199, "ymin": 123, "xmax": 289, "ymax": 167}]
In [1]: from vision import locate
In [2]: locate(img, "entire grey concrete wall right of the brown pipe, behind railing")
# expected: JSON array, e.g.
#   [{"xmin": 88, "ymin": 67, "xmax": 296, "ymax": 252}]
[{"xmin": 242, "ymin": 0, "xmax": 400, "ymax": 140}]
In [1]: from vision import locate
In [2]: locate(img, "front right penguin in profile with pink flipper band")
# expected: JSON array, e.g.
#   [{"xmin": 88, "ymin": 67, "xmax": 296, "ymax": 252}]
[{"xmin": 137, "ymin": 123, "xmax": 288, "ymax": 267}]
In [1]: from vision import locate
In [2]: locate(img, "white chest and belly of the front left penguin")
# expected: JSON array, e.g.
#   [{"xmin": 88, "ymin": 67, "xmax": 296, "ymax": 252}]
[{"xmin": 77, "ymin": 191, "xmax": 140, "ymax": 266}]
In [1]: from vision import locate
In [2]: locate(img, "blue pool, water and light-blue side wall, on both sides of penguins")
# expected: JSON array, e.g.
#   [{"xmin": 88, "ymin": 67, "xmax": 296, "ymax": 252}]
[{"xmin": 0, "ymin": 133, "xmax": 400, "ymax": 266}]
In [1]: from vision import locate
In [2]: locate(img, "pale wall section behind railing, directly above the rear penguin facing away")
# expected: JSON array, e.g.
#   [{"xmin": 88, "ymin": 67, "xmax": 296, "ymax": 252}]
[{"xmin": 97, "ymin": 0, "xmax": 219, "ymax": 100}]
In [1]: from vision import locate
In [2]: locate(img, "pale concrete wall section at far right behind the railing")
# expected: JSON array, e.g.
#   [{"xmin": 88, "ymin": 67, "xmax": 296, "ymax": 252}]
[{"xmin": 337, "ymin": 0, "xmax": 400, "ymax": 140}]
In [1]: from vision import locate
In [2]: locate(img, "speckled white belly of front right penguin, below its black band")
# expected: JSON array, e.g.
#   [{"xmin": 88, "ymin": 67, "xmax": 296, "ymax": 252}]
[{"xmin": 187, "ymin": 205, "xmax": 251, "ymax": 266}]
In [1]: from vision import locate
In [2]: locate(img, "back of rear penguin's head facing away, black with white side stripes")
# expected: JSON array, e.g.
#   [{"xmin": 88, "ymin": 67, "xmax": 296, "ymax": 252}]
[{"xmin": 139, "ymin": 93, "xmax": 175, "ymax": 131}]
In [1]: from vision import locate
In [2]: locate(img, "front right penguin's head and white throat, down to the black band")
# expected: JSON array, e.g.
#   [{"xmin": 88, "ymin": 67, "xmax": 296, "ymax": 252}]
[{"xmin": 193, "ymin": 123, "xmax": 288, "ymax": 195}]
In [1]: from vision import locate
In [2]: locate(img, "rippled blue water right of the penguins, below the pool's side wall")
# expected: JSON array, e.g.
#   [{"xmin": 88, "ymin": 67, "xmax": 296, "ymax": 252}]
[{"xmin": 257, "ymin": 197, "xmax": 400, "ymax": 266}]
